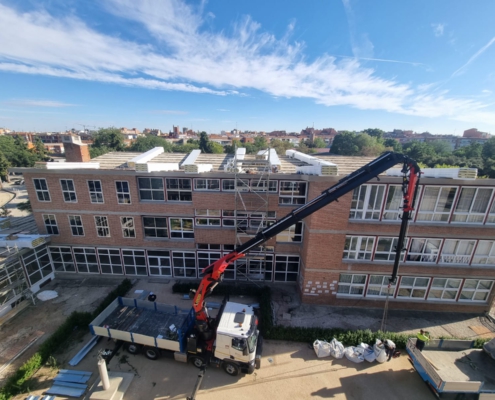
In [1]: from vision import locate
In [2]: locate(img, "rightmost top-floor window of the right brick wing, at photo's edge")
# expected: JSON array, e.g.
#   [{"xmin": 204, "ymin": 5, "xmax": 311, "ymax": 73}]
[{"xmin": 452, "ymin": 187, "xmax": 493, "ymax": 224}]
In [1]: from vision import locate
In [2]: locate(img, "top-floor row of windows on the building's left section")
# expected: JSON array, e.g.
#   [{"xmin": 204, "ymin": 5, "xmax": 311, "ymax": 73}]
[{"xmin": 33, "ymin": 178, "xmax": 307, "ymax": 204}]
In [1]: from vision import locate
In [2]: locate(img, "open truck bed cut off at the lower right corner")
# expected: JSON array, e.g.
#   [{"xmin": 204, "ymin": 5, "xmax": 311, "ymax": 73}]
[{"xmin": 406, "ymin": 338, "xmax": 495, "ymax": 400}]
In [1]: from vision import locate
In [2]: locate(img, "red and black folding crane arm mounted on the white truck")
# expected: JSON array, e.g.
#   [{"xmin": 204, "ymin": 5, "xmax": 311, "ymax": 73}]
[{"xmin": 193, "ymin": 152, "xmax": 420, "ymax": 322}]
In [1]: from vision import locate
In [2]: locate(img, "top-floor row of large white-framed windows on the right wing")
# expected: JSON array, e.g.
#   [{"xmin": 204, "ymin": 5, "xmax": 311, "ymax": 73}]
[{"xmin": 349, "ymin": 184, "xmax": 495, "ymax": 224}]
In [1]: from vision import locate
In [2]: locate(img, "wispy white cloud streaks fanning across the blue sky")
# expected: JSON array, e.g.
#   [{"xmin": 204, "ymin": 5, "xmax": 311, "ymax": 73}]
[{"xmin": 0, "ymin": 0, "xmax": 491, "ymax": 126}]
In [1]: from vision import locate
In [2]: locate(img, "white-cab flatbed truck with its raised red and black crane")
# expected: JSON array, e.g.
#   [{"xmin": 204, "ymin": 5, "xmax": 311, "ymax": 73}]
[{"xmin": 91, "ymin": 152, "xmax": 421, "ymax": 376}]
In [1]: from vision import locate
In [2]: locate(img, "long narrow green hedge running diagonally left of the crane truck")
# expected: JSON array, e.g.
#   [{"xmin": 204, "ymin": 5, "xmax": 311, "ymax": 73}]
[{"xmin": 0, "ymin": 279, "xmax": 132, "ymax": 400}]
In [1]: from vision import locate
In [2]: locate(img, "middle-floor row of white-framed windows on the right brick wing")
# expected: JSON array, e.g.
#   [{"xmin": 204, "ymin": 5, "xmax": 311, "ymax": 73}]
[{"xmin": 343, "ymin": 236, "xmax": 495, "ymax": 266}]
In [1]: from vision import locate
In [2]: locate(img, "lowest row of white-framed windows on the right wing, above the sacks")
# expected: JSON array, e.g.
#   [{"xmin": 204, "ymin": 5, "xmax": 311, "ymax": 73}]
[{"xmin": 337, "ymin": 274, "xmax": 493, "ymax": 302}]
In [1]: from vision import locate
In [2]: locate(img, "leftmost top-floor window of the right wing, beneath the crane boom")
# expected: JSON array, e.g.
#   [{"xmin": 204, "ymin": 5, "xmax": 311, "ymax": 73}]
[{"xmin": 349, "ymin": 185, "xmax": 385, "ymax": 220}]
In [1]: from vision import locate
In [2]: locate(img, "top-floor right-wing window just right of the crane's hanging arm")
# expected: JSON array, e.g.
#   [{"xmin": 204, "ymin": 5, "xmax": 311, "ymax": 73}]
[{"xmin": 417, "ymin": 186, "xmax": 457, "ymax": 222}]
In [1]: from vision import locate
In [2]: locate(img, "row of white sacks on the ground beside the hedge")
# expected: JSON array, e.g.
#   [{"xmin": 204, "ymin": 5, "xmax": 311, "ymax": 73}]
[{"xmin": 313, "ymin": 338, "xmax": 395, "ymax": 363}]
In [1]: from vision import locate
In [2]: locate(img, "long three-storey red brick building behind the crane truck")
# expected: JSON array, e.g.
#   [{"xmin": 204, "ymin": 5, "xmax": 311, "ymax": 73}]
[{"xmin": 15, "ymin": 145, "xmax": 495, "ymax": 313}]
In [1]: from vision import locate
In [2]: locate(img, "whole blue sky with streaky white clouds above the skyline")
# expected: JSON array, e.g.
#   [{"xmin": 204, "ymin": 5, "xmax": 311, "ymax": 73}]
[{"xmin": 0, "ymin": 0, "xmax": 495, "ymax": 135}]
